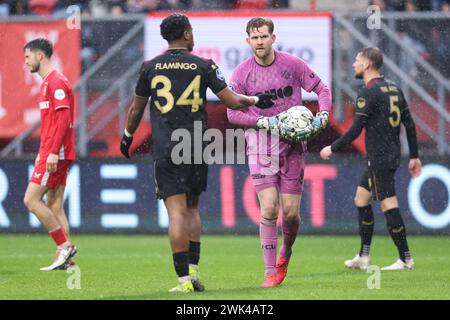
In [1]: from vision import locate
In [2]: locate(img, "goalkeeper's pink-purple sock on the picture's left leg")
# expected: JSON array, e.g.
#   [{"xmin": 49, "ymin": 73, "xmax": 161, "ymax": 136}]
[{"xmin": 259, "ymin": 218, "xmax": 278, "ymax": 275}]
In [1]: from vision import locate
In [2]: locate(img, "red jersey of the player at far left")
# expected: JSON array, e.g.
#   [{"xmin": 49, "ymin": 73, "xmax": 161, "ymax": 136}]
[{"xmin": 39, "ymin": 70, "xmax": 75, "ymax": 160}]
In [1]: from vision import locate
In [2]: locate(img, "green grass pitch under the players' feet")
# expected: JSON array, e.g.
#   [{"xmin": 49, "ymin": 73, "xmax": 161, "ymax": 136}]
[{"xmin": 0, "ymin": 234, "xmax": 450, "ymax": 300}]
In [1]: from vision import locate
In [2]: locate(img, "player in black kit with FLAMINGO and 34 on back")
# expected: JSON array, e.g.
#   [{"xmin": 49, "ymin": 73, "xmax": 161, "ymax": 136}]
[{"xmin": 120, "ymin": 14, "xmax": 273, "ymax": 292}]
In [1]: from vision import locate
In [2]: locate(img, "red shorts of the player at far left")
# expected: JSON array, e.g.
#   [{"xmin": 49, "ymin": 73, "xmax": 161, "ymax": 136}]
[{"xmin": 30, "ymin": 157, "xmax": 73, "ymax": 189}]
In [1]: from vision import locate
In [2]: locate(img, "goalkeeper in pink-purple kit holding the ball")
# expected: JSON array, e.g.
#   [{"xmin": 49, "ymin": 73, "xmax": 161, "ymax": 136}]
[{"xmin": 227, "ymin": 18, "xmax": 331, "ymax": 287}]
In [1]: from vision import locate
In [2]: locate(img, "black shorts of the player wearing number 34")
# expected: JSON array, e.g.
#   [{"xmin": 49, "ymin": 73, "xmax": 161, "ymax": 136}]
[{"xmin": 153, "ymin": 158, "xmax": 208, "ymax": 199}]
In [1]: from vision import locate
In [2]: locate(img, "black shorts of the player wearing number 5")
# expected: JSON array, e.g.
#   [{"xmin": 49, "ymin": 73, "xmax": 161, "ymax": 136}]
[{"xmin": 359, "ymin": 168, "xmax": 396, "ymax": 201}]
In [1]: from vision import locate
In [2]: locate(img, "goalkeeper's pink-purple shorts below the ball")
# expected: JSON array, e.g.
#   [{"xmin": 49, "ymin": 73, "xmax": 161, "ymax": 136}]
[{"xmin": 249, "ymin": 153, "xmax": 306, "ymax": 194}]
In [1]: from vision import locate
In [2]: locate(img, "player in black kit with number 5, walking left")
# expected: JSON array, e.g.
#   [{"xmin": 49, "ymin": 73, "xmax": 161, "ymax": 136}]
[{"xmin": 320, "ymin": 48, "xmax": 422, "ymax": 270}]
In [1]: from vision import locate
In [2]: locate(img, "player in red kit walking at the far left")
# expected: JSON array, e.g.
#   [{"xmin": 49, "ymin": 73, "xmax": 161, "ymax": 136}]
[{"xmin": 24, "ymin": 38, "xmax": 77, "ymax": 271}]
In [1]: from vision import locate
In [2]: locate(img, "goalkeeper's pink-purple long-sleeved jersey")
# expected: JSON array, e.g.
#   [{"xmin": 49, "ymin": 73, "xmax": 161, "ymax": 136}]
[{"xmin": 227, "ymin": 51, "xmax": 321, "ymax": 155}]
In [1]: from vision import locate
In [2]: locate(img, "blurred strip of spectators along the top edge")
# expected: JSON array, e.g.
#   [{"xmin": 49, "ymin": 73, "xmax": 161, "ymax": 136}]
[{"xmin": 0, "ymin": 0, "xmax": 450, "ymax": 17}]
